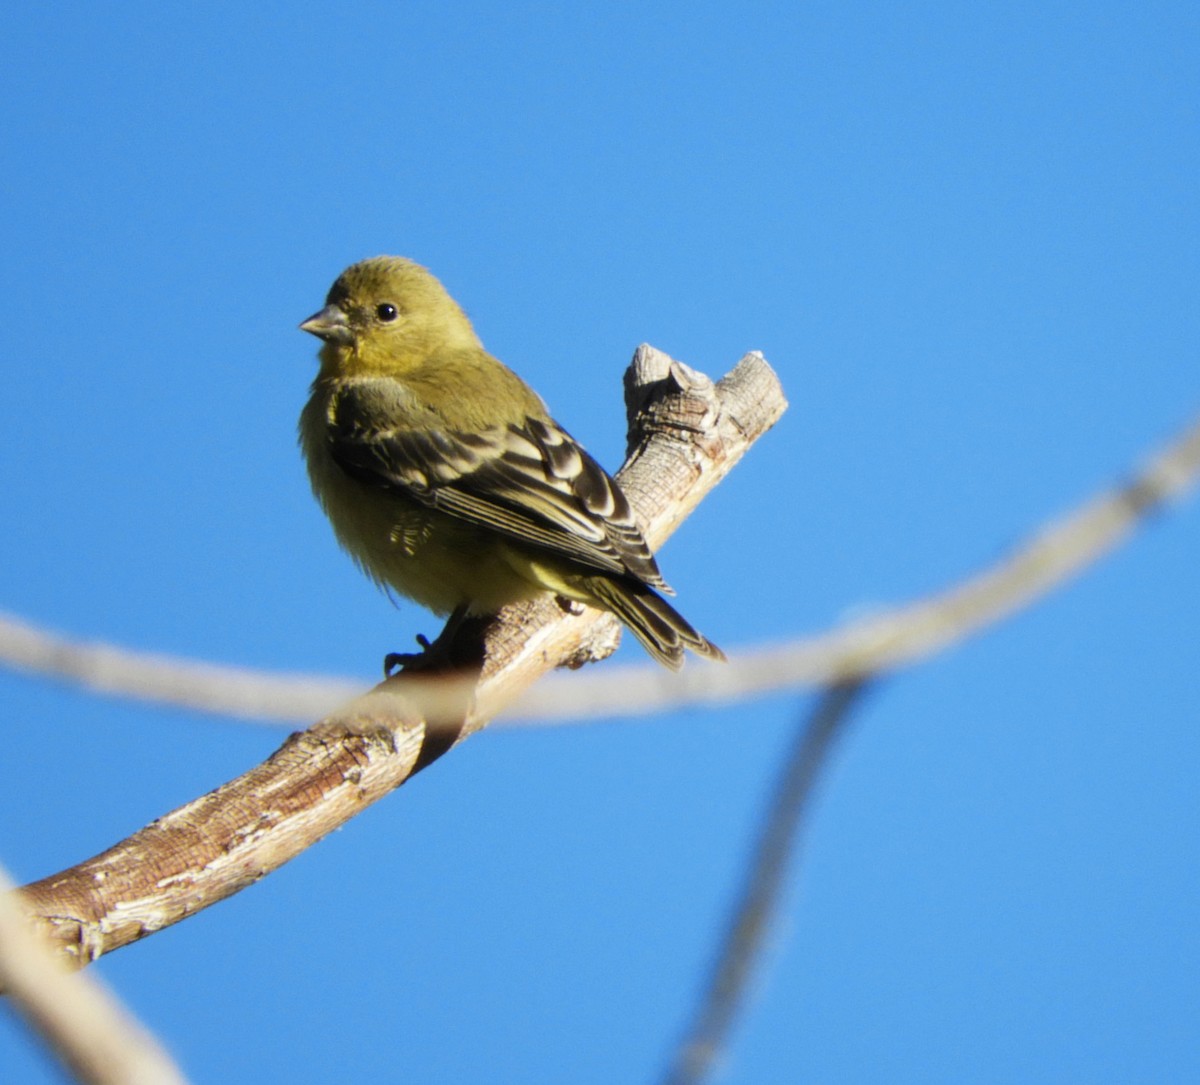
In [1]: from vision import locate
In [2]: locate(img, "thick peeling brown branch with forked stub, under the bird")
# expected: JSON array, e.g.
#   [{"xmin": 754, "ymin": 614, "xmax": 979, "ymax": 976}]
[{"xmin": 22, "ymin": 346, "xmax": 786, "ymax": 965}]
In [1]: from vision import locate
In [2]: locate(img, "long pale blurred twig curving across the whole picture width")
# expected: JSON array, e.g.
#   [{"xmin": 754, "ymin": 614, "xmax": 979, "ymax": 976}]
[{"xmin": 0, "ymin": 420, "xmax": 1200, "ymax": 725}]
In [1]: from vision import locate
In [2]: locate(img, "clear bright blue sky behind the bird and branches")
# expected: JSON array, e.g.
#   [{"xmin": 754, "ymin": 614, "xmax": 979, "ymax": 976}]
[{"xmin": 0, "ymin": 2, "xmax": 1200, "ymax": 1085}]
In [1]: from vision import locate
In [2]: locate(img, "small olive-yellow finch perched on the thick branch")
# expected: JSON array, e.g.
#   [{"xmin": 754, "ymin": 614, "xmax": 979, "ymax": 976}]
[{"xmin": 300, "ymin": 256, "xmax": 724, "ymax": 667}]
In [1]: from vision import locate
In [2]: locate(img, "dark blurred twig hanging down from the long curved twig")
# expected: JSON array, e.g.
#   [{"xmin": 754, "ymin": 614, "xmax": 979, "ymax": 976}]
[{"xmin": 664, "ymin": 679, "xmax": 866, "ymax": 1085}]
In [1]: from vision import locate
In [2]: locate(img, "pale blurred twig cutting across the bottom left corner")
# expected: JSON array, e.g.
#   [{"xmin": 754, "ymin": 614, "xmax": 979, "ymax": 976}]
[{"xmin": 0, "ymin": 870, "xmax": 185, "ymax": 1085}]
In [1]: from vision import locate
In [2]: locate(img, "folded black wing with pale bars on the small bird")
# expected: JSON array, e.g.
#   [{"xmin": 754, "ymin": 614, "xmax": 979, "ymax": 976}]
[{"xmin": 329, "ymin": 386, "xmax": 670, "ymax": 592}]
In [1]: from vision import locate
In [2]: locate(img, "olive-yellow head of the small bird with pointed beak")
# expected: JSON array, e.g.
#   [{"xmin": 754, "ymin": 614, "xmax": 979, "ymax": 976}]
[{"xmin": 300, "ymin": 256, "xmax": 479, "ymax": 376}]
